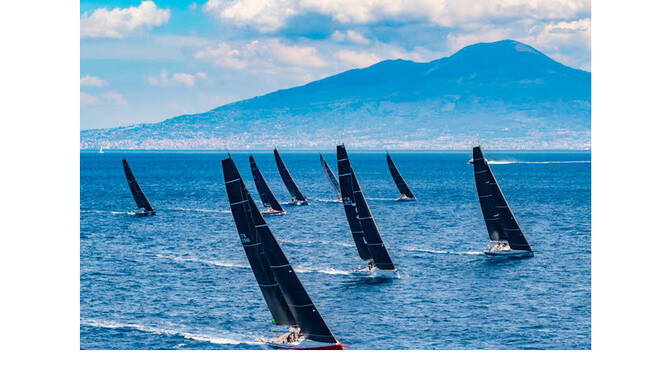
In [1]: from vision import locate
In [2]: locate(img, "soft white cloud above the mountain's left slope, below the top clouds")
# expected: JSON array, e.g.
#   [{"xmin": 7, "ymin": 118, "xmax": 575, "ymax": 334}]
[{"xmin": 195, "ymin": 39, "xmax": 326, "ymax": 72}]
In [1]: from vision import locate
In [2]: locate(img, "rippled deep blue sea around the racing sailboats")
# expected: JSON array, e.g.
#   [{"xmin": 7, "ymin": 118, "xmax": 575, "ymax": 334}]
[{"xmin": 80, "ymin": 151, "xmax": 591, "ymax": 349}]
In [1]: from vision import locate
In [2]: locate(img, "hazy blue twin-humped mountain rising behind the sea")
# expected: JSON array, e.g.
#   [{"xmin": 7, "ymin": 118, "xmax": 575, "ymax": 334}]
[{"xmin": 80, "ymin": 40, "xmax": 591, "ymax": 149}]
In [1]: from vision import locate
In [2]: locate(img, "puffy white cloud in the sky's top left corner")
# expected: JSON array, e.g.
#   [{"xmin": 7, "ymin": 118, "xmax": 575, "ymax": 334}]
[{"xmin": 80, "ymin": 1, "xmax": 170, "ymax": 38}]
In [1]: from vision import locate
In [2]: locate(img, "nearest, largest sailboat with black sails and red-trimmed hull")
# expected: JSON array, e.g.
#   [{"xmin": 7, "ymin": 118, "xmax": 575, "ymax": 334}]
[{"xmin": 222, "ymin": 157, "xmax": 344, "ymax": 350}]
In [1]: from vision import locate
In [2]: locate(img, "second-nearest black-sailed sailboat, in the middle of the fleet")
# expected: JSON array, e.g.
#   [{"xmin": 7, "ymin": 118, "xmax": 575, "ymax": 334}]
[{"xmin": 337, "ymin": 144, "xmax": 396, "ymax": 272}]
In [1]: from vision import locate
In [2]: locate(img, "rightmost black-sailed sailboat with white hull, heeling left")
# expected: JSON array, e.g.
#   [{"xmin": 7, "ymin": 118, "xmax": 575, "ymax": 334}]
[{"xmin": 472, "ymin": 146, "xmax": 534, "ymax": 257}]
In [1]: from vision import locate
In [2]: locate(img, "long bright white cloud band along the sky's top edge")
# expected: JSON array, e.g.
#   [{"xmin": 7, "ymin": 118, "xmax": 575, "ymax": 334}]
[{"xmin": 204, "ymin": 0, "xmax": 591, "ymax": 32}]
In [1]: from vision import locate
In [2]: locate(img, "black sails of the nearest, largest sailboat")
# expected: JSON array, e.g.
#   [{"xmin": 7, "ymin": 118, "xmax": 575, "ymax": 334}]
[{"xmin": 222, "ymin": 158, "xmax": 338, "ymax": 343}]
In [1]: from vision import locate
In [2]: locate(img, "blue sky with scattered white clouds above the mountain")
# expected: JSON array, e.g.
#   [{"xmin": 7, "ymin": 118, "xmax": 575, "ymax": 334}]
[{"xmin": 80, "ymin": 0, "xmax": 591, "ymax": 129}]
